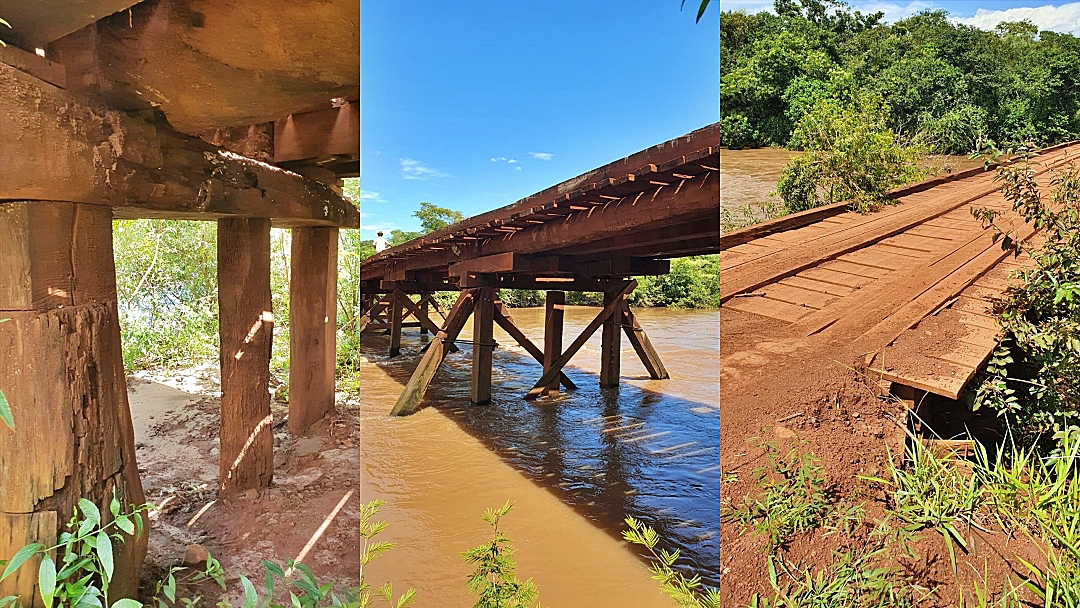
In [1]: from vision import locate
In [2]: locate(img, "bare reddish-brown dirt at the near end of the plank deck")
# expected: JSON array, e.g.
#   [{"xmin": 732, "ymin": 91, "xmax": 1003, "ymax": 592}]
[{"xmin": 720, "ymin": 309, "xmax": 1041, "ymax": 606}]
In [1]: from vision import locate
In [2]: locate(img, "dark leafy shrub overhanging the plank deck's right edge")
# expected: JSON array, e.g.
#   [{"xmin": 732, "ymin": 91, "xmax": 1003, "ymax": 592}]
[{"xmin": 971, "ymin": 154, "xmax": 1080, "ymax": 443}]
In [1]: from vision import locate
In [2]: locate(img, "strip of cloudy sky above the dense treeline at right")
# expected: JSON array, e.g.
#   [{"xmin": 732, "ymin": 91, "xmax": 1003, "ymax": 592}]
[{"xmin": 714, "ymin": 0, "xmax": 1080, "ymax": 35}]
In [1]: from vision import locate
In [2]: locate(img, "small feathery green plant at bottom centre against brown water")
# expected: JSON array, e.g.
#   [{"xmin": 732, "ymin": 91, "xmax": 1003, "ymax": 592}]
[{"xmin": 461, "ymin": 500, "xmax": 540, "ymax": 608}]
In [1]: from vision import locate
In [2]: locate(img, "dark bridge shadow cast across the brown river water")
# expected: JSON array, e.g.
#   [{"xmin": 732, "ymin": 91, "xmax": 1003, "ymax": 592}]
[{"xmin": 362, "ymin": 323, "xmax": 720, "ymax": 586}]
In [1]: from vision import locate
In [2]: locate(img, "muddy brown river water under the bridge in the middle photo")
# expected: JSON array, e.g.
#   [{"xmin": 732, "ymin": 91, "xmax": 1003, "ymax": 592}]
[{"xmin": 360, "ymin": 307, "xmax": 720, "ymax": 607}]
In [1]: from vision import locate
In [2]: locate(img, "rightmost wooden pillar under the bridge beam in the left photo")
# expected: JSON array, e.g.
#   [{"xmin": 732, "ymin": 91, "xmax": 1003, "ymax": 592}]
[{"xmin": 288, "ymin": 227, "xmax": 338, "ymax": 435}]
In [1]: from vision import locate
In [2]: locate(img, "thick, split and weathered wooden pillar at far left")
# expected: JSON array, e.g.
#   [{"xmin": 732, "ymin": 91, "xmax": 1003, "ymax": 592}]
[{"xmin": 0, "ymin": 201, "xmax": 149, "ymax": 606}]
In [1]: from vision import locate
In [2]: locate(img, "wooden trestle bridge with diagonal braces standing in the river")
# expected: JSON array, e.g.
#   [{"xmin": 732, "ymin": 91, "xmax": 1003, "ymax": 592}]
[{"xmin": 359, "ymin": 124, "xmax": 720, "ymax": 415}]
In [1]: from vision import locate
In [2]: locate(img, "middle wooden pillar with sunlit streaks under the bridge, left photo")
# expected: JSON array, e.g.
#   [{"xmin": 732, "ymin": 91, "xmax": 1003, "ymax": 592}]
[{"xmin": 217, "ymin": 218, "xmax": 273, "ymax": 494}]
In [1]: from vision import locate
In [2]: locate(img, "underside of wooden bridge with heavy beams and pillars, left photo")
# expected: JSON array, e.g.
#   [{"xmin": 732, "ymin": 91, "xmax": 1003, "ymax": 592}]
[{"xmin": 0, "ymin": 0, "xmax": 360, "ymax": 605}]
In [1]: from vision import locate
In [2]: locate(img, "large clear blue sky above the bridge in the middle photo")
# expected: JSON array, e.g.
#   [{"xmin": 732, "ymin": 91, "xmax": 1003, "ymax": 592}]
[{"xmin": 361, "ymin": 0, "xmax": 719, "ymax": 238}]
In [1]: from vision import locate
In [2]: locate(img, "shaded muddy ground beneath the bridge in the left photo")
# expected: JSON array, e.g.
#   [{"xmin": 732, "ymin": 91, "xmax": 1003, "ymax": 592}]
[{"xmin": 127, "ymin": 364, "xmax": 360, "ymax": 604}]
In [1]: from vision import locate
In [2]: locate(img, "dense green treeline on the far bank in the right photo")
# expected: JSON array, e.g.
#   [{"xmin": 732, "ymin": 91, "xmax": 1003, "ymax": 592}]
[{"xmin": 720, "ymin": 0, "xmax": 1080, "ymax": 153}]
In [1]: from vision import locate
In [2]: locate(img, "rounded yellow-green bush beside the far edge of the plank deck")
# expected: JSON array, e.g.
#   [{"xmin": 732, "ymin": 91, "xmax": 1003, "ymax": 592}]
[{"xmin": 777, "ymin": 96, "xmax": 924, "ymax": 213}]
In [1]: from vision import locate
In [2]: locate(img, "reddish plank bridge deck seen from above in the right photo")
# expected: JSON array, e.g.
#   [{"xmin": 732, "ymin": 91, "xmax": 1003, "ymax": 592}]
[{"xmin": 720, "ymin": 143, "xmax": 1080, "ymax": 412}]
